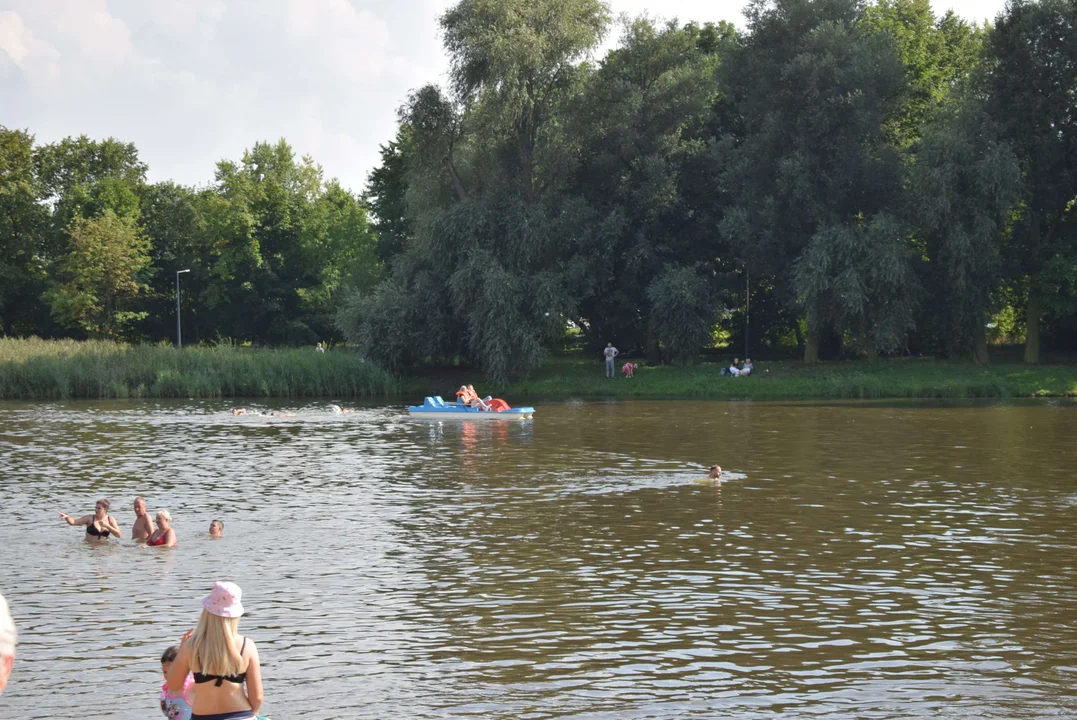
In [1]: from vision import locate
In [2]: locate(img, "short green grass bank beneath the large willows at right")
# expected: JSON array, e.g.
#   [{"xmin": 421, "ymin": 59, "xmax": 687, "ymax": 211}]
[{"xmin": 484, "ymin": 358, "xmax": 1077, "ymax": 400}]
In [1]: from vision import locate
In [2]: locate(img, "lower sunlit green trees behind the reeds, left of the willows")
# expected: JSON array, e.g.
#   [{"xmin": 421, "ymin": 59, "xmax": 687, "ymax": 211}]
[{"xmin": 0, "ymin": 136, "xmax": 380, "ymax": 344}]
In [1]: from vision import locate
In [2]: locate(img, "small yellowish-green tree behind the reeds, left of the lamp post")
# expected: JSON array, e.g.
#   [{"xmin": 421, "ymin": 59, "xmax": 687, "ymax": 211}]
[{"xmin": 48, "ymin": 210, "xmax": 150, "ymax": 338}]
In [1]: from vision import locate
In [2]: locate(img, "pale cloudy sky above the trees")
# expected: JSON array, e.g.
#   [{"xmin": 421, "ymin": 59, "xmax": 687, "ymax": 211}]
[{"xmin": 0, "ymin": 0, "xmax": 1004, "ymax": 192}]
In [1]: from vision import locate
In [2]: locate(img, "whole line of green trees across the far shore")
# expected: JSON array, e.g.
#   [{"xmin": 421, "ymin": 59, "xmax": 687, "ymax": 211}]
[{"xmin": 0, "ymin": 0, "xmax": 1077, "ymax": 380}]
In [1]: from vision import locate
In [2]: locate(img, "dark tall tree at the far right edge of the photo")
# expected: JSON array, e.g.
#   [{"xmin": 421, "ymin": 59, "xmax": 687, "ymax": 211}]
[{"xmin": 987, "ymin": 0, "xmax": 1077, "ymax": 363}]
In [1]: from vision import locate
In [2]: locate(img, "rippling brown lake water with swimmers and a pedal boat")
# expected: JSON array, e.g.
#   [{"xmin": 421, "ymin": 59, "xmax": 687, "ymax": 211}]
[{"xmin": 0, "ymin": 401, "xmax": 1077, "ymax": 720}]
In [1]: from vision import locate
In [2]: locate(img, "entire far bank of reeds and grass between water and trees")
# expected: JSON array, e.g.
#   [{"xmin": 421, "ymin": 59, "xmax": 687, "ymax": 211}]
[{"xmin": 0, "ymin": 339, "xmax": 1077, "ymax": 403}]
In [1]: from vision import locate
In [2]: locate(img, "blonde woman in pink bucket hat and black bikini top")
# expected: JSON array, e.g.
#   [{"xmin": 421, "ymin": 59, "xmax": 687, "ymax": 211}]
[{"xmin": 168, "ymin": 582, "xmax": 263, "ymax": 720}]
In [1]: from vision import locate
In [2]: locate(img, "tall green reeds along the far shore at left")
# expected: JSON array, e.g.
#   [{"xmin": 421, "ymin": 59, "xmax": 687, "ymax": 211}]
[{"xmin": 0, "ymin": 338, "xmax": 398, "ymax": 399}]
